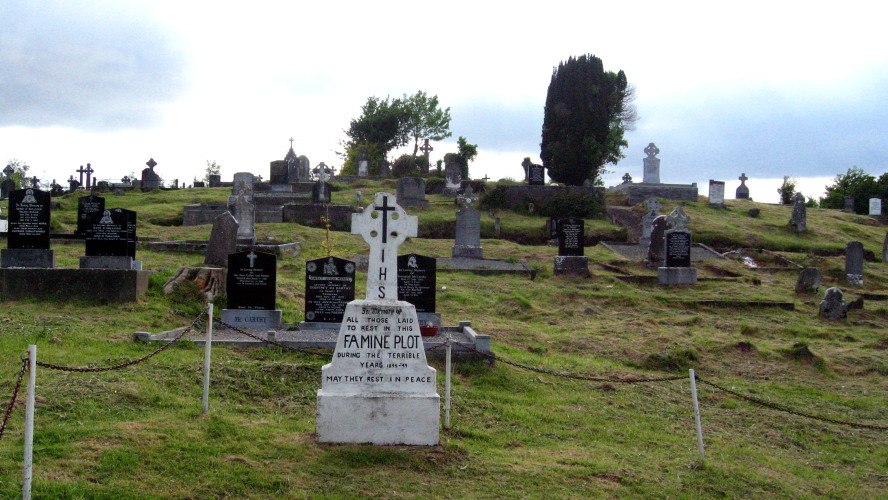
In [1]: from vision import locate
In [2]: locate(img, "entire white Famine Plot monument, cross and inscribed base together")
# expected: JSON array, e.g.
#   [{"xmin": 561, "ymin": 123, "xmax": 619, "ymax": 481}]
[{"xmin": 317, "ymin": 193, "xmax": 440, "ymax": 445}]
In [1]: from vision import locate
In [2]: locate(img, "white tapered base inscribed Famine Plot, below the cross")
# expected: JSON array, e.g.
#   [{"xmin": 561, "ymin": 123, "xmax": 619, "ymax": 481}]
[{"xmin": 317, "ymin": 300, "xmax": 441, "ymax": 446}]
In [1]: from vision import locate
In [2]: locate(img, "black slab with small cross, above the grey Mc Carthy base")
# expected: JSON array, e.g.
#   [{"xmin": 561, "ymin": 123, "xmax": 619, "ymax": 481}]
[{"xmin": 225, "ymin": 250, "xmax": 277, "ymax": 310}]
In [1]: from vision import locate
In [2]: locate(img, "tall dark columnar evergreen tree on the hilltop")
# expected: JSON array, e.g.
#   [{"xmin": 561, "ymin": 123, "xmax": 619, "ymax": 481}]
[{"xmin": 540, "ymin": 54, "xmax": 637, "ymax": 186}]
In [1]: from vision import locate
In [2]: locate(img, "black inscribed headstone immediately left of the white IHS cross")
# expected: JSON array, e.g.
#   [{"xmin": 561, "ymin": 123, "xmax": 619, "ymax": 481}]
[{"xmin": 305, "ymin": 257, "xmax": 355, "ymax": 323}]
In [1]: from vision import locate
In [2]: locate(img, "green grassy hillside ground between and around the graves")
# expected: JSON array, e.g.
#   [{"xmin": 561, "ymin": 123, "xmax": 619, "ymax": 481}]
[{"xmin": 0, "ymin": 181, "xmax": 888, "ymax": 498}]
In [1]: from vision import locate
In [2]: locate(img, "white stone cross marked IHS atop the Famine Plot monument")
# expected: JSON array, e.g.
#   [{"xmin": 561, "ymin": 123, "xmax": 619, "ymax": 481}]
[{"xmin": 351, "ymin": 193, "xmax": 418, "ymax": 300}]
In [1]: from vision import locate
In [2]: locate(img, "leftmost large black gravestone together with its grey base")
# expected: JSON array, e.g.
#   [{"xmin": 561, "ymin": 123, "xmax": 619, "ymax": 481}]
[{"xmin": 0, "ymin": 189, "xmax": 55, "ymax": 268}]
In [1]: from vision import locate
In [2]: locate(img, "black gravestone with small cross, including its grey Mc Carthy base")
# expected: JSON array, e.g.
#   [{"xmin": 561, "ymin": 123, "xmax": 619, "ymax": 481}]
[{"xmin": 222, "ymin": 250, "xmax": 281, "ymax": 328}]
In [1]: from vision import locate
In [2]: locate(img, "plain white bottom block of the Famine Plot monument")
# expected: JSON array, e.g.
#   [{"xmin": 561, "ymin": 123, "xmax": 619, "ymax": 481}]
[{"xmin": 317, "ymin": 389, "xmax": 441, "ymax": 446}]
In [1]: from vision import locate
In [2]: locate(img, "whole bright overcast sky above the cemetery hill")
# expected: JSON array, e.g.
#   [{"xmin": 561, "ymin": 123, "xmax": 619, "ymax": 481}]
[{"xmin": 0, "ymin": 0, "xmax": 888, "ymax": 201}]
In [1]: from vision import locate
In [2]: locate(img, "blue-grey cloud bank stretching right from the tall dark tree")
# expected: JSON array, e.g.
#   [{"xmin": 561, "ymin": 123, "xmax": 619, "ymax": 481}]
[{"xmin": 615, "ymin": 78, "xmax": 888, "ymax": 182}]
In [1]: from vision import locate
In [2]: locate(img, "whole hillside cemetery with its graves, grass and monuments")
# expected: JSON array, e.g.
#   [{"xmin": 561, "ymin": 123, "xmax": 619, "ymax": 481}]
[{"xmin": 0, "ymin": 177, "xmax": 888, "ymax": 498}]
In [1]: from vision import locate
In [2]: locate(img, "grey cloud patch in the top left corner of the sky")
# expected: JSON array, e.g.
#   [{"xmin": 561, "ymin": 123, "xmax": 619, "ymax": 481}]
[{"xmin": 0, "ymin": 2, "xmax": 185, "ymax": 130}]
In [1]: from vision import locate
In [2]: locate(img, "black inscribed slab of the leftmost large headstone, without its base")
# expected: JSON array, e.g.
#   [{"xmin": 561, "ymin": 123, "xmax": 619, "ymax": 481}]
[{"xmin": 7, "ymin": 189, "xmax": 51, "ymax": 250}]
